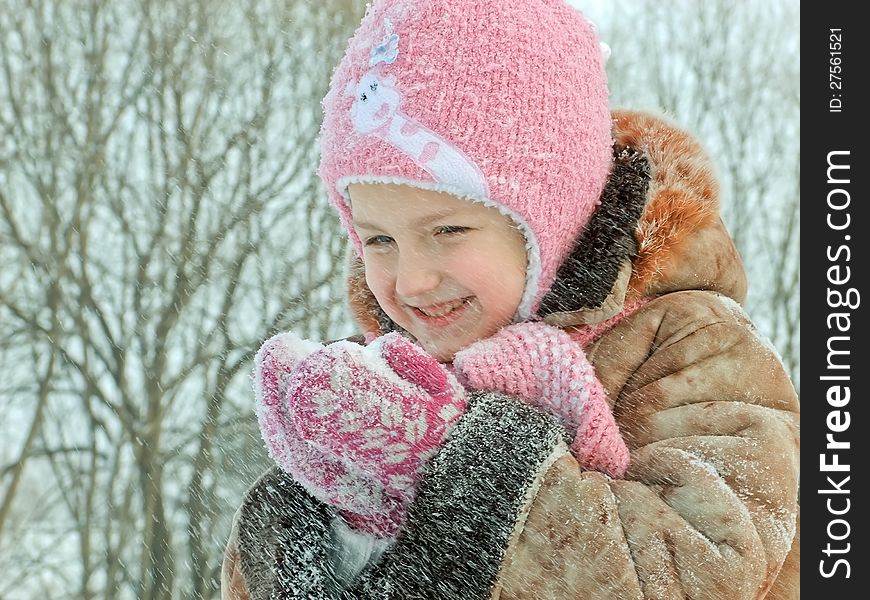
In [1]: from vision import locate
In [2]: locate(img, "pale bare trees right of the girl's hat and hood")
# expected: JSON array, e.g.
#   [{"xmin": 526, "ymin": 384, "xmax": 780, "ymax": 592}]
[{"xmin": 574, "ymin": 0, "xmax": 800, "ymax": 385}]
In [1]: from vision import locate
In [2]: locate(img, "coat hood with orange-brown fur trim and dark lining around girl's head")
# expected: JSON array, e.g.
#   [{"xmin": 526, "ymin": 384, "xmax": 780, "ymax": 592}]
[{"xmin": 347, "ymin": 110, "xmax": 747, "ymax": 334}]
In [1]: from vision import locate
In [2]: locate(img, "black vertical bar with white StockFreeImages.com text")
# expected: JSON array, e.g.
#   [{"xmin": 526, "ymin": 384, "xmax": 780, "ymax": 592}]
[{"xmin": 801, "ymin": 2, "xmax": 870, "ymax": 599}]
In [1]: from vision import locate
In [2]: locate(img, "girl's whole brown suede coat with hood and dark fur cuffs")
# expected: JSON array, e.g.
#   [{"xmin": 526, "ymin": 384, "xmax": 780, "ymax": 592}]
[{"xmin": 222, "ymin": 111, "xmax": 799, "ymax": 600}]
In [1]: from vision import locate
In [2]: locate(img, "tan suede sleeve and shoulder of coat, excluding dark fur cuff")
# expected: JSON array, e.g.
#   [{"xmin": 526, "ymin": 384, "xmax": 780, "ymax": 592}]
[{"xmin": 497, "ymin": 292, "xmax": 799, "ymax": 600}]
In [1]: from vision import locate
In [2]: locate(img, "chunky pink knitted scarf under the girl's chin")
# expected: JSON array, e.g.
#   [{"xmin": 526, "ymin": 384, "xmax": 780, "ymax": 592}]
[{"xmin": 453, "ymin": 323, "xmax": 629, "ymax": 477}]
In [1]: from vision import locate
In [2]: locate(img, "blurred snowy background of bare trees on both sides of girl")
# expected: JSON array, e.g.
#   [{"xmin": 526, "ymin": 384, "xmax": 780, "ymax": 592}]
[{"xmin": 0, "ymin": 0, "xmax": 800, "ymax": 600}]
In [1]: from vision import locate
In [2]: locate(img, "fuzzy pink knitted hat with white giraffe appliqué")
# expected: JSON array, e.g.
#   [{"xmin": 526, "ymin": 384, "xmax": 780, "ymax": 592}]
[{"xmin": 319, "ymin": 0, "xmax": 612, "ymax": 320}]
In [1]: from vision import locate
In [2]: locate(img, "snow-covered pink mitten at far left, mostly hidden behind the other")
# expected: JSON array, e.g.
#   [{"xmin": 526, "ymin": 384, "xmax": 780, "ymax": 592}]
[{"xmin": 253, "ymin": 333, "xmax": 399, "ymax": 533}]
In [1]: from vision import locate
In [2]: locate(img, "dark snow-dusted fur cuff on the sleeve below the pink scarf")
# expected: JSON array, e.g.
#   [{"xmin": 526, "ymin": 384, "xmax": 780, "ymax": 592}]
[{"xmin": 349, "ymin": 394, "xmax": 568, "ymax": 600}]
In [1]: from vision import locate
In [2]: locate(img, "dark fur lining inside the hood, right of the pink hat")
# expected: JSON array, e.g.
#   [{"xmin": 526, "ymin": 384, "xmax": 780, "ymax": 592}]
[{"xmin": 538, "ymin": 146, "xmax": 650, "ymax": 324}]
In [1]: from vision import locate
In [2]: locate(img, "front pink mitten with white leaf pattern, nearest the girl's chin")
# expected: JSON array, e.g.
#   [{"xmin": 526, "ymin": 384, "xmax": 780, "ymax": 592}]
[{"xmin": 287, "ymin": 333, "xmax": 466, "ymax": 536}]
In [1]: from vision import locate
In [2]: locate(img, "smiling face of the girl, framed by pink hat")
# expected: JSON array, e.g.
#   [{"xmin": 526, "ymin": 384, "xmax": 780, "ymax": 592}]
[{"xmin": 349, "ymin": 184, "xmax": 527, "ymax": 362}]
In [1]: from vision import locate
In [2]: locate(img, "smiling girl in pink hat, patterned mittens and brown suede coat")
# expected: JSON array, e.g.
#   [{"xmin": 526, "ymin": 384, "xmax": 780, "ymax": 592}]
[{"xmin": 222, "ymin": 0, "xmax": 799, "ymax": 600}]
